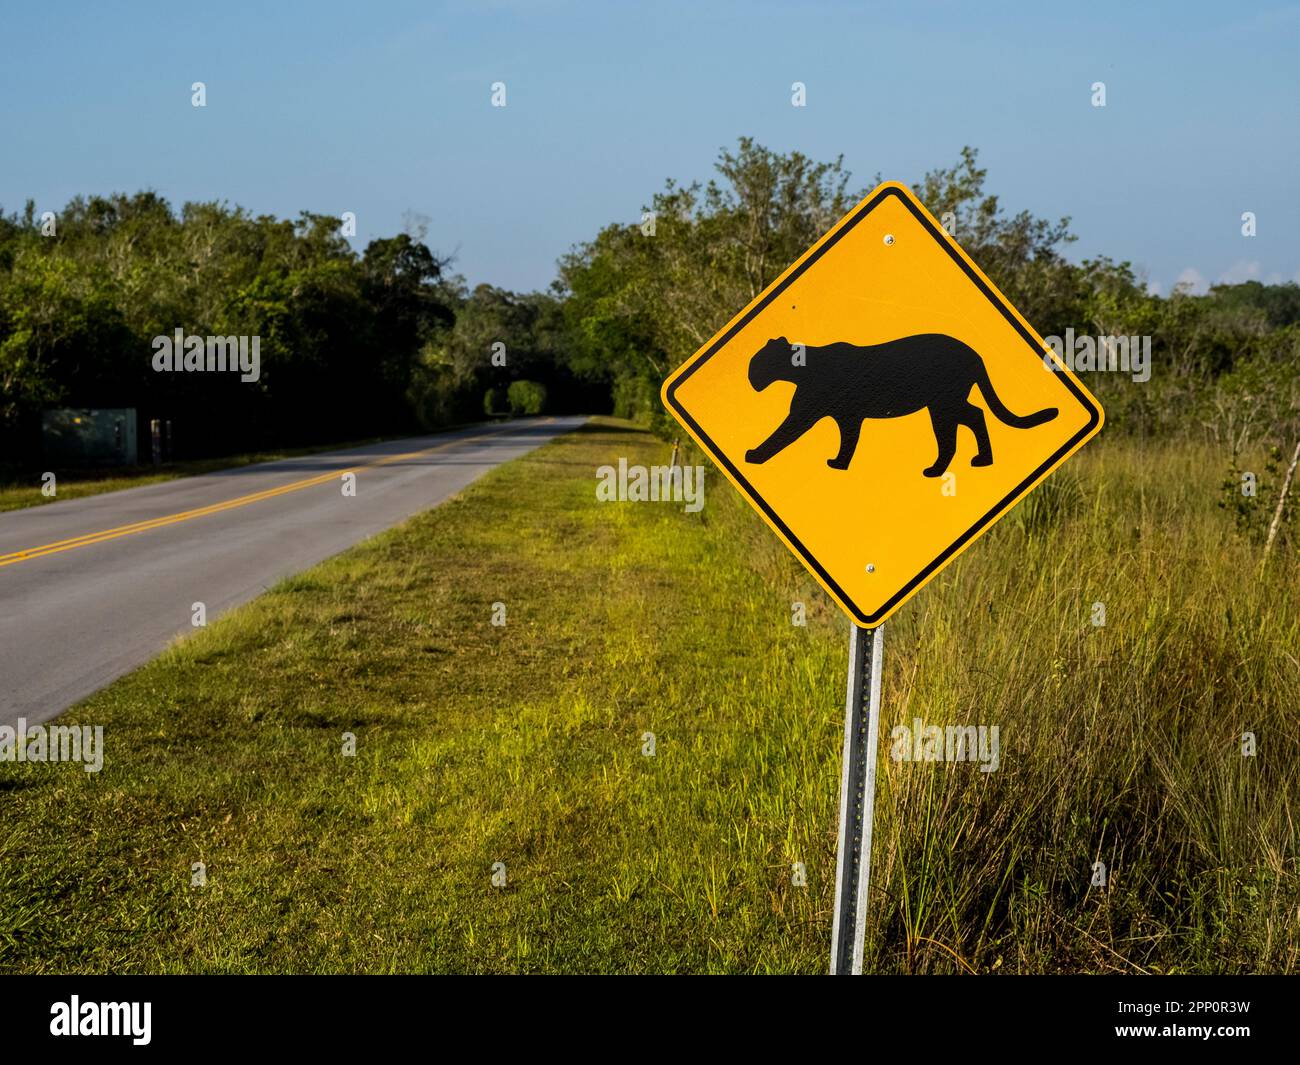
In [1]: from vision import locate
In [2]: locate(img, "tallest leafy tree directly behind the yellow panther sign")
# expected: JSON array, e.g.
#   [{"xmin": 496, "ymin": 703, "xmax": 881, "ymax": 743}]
[{"xmin": 559, "ymin": 138, "xmax": 1080, "ymax": 425}]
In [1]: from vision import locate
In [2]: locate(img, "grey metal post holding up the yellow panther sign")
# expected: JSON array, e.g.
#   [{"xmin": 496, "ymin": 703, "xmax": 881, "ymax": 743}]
[{"xmin": 831, "ymin": 625, "xmax": 884, "ymax": 977}]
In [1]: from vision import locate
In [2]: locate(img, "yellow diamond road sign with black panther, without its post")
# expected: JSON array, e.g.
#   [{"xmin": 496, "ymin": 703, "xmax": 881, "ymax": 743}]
[{"xmin": 663, "ymin": 182, "xmax": 1102, "ymax": 627}]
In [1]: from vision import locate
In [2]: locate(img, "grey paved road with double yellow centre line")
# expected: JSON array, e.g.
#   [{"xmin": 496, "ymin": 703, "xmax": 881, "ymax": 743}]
[{"xmin": 0, "ymin": 417, "xmax": 585, "ymax": 724}]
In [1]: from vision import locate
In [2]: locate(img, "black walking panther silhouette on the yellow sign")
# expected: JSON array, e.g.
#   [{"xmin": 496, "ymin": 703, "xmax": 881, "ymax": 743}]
[{"xmin": 745, "ymin": 333, "xmax": 1057, "ymax": 477}]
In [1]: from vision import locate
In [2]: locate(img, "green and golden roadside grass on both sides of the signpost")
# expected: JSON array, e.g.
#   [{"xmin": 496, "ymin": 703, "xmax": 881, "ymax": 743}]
[{"xmin": 0, "ymin": 420, "xmax": 1300, "ymax": 973}]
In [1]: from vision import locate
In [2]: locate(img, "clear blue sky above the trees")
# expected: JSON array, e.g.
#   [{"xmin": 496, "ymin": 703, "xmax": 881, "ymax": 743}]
[{"xmin": 0, "ymin": 0, "xmax": 1300, "ymax": 293}]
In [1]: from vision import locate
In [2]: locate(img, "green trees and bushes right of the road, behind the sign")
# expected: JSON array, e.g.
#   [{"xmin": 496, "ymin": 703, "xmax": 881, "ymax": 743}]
[{"xmin": 560, "ymin": 139, "xmax": 1300, "ymax": 454}]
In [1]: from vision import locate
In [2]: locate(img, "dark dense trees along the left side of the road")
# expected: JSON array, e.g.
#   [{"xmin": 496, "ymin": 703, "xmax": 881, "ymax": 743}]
[{"xmin": 0, "ymin": 200, "xmax": 601, "ymax": 463}]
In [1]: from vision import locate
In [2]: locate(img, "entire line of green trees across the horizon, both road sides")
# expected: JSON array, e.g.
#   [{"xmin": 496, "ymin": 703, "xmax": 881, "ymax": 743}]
[{"xmin": 0, "ymin": 138, "xmax": 1300, "ymax": 462}]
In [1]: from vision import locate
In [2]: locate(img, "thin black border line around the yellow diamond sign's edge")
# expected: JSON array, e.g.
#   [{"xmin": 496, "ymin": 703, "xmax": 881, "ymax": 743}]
[{"xmin": 666, "ymin": 189, "xmax": 1101, "ymax": 628}]
